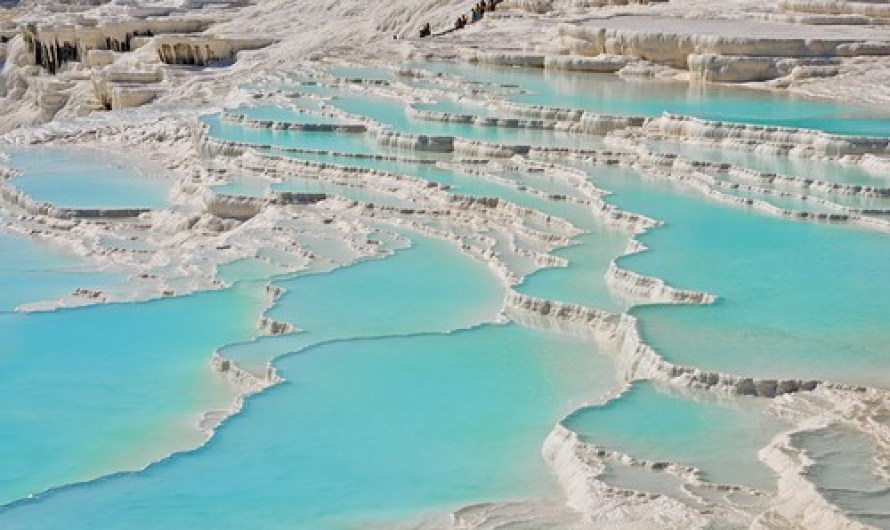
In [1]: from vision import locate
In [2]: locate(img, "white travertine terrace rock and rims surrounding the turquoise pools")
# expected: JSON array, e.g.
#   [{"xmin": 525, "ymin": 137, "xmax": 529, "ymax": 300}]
[{"xmin": 0, "ymin": 0, "xmax": 890, "ymax": 528}]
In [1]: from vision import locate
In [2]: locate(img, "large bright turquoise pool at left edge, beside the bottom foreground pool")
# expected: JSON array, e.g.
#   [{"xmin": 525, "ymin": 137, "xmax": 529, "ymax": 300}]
[{"xmin": 0, "ymin": 285, "xmax": 265, "ymax": 503}]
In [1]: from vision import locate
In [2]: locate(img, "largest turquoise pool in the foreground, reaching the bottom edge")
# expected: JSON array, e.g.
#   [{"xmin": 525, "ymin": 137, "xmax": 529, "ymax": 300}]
[{"xmin": 0, "ymin": 326, "xmax": 610, "ymax": 529}]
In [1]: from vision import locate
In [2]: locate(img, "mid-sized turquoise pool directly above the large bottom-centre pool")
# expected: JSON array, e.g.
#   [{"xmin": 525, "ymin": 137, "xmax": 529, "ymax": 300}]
[{"xmin": 223, "ymin": 236, "xmax": 504, "ymax": 372}]
